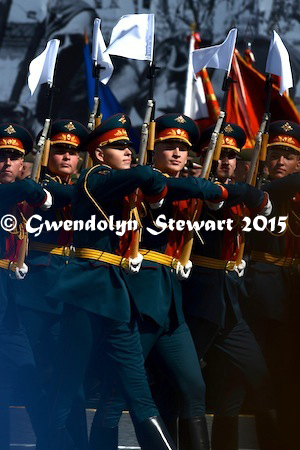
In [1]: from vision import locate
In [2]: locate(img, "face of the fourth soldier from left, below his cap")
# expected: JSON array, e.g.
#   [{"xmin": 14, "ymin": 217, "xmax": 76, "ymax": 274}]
[{"xmin": 154, "ymin": 139, "xmax": 189, "ymax": 177}]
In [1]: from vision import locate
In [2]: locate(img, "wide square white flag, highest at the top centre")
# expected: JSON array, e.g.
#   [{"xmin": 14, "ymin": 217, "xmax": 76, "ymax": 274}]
[{"xmin": 106, "ymin": 14, "xmax": 154, "ymax": 61}]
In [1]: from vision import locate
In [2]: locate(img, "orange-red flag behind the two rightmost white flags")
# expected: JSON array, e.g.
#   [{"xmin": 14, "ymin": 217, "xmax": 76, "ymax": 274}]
[{"xmin": 227, "ymin": 50, "xmax": 299, "ymax": 148}]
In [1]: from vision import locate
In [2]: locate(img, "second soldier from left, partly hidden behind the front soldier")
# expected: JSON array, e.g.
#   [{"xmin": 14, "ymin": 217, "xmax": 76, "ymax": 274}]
[{"xmin": 16, "ymin": 119, "xmax": 88, "ymax": 449}]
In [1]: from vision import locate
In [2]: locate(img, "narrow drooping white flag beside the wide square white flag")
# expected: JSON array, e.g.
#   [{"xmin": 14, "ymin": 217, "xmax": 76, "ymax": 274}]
[{"xmin": 92, "ymin": 18, "xmax": 114, "ymax": 84}]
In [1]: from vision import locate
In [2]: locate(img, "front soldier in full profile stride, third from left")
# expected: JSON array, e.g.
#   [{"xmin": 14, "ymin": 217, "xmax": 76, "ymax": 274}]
[{"xmin": 45, "ymin": 114, "xmax": 174, "ymax": 450}]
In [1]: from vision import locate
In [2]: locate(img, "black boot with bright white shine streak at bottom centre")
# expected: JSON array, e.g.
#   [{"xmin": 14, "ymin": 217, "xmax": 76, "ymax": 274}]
[{"xmin": 135, "ymin": 416, "xmax": 176, "ymax": 450}]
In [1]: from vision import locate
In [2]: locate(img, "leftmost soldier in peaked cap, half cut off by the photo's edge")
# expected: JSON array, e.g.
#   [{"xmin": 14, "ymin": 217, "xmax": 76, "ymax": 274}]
[{"xmin": 0, "ymin": 123, "xmax": 51, "ymax": 450}]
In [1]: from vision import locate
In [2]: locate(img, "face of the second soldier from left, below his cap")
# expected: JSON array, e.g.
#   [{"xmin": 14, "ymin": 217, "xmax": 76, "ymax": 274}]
[{"xmin": 48, "ymin": 145, "xmax": 79, "ymax": 179}]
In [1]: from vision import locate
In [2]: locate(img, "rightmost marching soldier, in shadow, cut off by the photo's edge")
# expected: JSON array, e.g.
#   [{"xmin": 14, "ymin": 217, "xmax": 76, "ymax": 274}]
[{"xmin": 244, "ymin": 120, "xmax": 300, "ymax": 449}]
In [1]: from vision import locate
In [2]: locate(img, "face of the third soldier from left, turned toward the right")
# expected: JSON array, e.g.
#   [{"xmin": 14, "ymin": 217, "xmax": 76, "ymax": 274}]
[{"xmin": 96, "ymin": 144, "xmax": 132, "ymax": 170}]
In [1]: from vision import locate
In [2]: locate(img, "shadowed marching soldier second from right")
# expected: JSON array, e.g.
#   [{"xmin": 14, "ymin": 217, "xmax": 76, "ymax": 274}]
[{"xmin": 183, "ymin": 123, "xmax": 277, "ymax": 450}]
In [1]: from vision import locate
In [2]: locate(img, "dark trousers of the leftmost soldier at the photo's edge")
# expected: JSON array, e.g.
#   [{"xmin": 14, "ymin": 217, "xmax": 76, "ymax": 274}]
[{"xmin": 0, "ymin": 323, "xmax": 46, "ymax": 450}]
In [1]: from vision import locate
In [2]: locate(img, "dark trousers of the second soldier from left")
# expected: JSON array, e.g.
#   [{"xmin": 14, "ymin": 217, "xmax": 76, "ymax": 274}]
[{"xmin": 18, "ymin": 306, "xmax": 88, "ymax": 450}]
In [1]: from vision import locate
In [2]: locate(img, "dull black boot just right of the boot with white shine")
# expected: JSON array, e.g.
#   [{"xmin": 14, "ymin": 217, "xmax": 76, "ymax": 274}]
[{"xmin": 179, "ymin": 416, "xmax": 210, "ymax": 450}]
